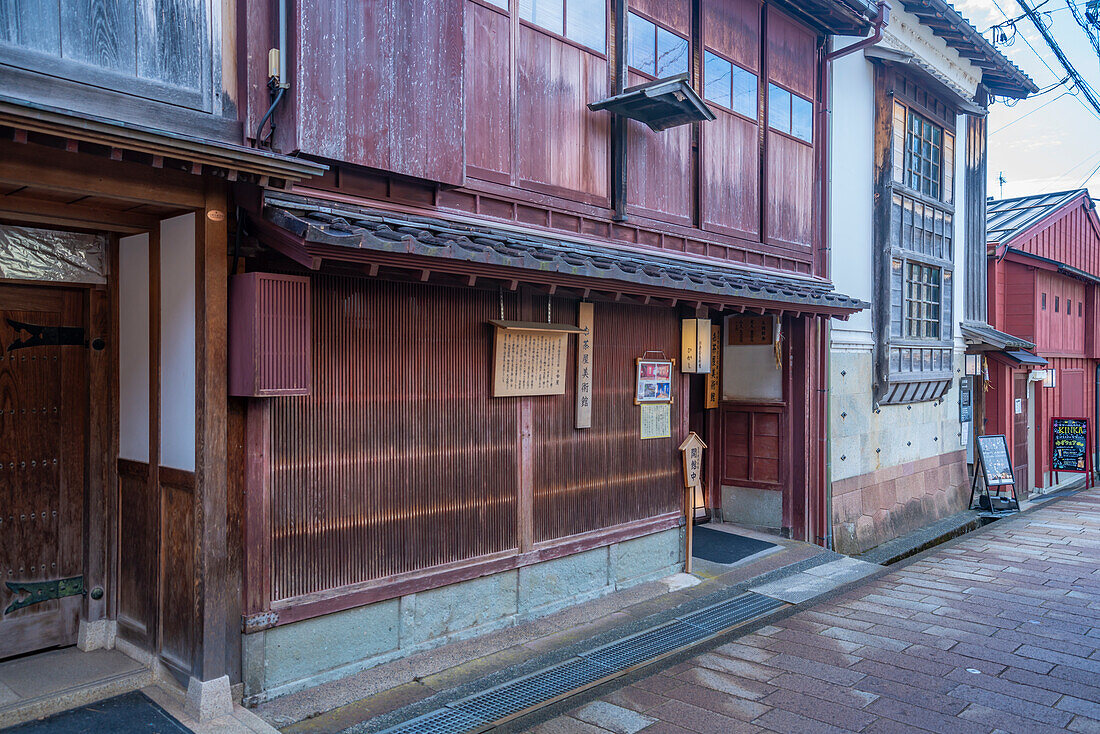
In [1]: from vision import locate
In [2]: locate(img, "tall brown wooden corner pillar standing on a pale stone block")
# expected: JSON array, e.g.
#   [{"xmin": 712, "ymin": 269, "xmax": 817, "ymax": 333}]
[{"xmin": 187, "ymin": 178, "xmax": 232, "ymax": 719}]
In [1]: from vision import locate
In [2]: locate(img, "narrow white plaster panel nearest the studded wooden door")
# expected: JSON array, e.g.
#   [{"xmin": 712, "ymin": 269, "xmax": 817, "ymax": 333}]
[{"xmin": 118, "ymin": 234, "xmax": 149, "ymax": 461}]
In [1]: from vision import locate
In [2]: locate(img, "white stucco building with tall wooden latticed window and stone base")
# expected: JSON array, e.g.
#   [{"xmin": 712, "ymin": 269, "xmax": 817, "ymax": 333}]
[{"xmin": 828, "ymin": 0, "xmax": 1036, "ymax": 552}]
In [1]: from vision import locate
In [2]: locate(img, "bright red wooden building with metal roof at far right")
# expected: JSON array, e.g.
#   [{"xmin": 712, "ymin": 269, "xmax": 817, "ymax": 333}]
[{"xmin": 985, "ymin": 189, "xmax": 1100, "ymax": 495}]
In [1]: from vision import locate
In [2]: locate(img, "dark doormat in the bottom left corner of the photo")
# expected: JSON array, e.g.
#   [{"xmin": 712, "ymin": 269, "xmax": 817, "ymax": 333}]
[{"xmin": 0, "ymin": 691, "xmax": 190, "ymax": 734}]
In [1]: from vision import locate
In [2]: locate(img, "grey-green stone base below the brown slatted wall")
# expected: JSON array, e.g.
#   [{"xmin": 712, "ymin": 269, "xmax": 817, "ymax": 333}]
[{"xmin": 242, "ymin": 528, "xmax": 684, "ymax": 703}]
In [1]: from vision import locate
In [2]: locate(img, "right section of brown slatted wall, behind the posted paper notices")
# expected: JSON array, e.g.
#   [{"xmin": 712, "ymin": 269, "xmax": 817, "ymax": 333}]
[{"xmin": 531, "ymin": 298, "xmax": 683, "ymax": 543}]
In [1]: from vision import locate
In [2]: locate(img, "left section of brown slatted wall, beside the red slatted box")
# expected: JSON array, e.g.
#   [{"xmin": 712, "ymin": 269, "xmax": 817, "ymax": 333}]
[{"xmin": 271, "ymin": 276, "xmax": 518, "ymax": 600}]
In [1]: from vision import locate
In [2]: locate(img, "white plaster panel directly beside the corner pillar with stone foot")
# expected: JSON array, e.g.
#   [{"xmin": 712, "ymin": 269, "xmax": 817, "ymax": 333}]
[{"xmin": 161, "ymin": 213, "xmax": 195, "ymax": 471}]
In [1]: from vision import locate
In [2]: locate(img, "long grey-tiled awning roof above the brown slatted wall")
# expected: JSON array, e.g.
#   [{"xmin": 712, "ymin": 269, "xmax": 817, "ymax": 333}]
[{"xmin": 253, "ymin": 193, "xmax": 869, "ymax": 318}]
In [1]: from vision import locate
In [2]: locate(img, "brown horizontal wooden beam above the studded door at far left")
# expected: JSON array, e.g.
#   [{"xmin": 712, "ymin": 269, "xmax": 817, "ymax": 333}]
[{"xmin": 0, "ymin": 142, "xmax": 205, "ymax": 209}]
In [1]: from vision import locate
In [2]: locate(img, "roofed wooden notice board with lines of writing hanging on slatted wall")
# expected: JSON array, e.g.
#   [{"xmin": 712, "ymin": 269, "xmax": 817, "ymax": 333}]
[{"xmin": 490, "ymin": 320, "xmax": 581, "ymax": 397}]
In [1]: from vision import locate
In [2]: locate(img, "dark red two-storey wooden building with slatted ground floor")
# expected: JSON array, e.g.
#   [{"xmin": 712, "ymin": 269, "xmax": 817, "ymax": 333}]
[{"xmin": 230, "ymin": 0, "xmax": 878, "ymax": 701}]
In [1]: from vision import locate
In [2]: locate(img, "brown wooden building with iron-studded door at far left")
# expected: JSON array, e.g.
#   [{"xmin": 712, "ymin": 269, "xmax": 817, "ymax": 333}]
[{"xmin": 0, "ymin": 2, "xmax": 323, "ymax": 725}]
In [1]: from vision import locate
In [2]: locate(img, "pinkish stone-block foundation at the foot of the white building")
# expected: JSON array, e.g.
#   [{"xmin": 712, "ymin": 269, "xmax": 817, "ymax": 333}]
[{"xmin": 833, "ymin": 450, "xmax": 970, "ymax": 555}]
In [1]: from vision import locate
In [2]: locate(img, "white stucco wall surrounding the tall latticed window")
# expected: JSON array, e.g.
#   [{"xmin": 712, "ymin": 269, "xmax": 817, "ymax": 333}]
[{"xmin": 828, "ymin": 8, "xmax": 979, "ymax": 488}]
